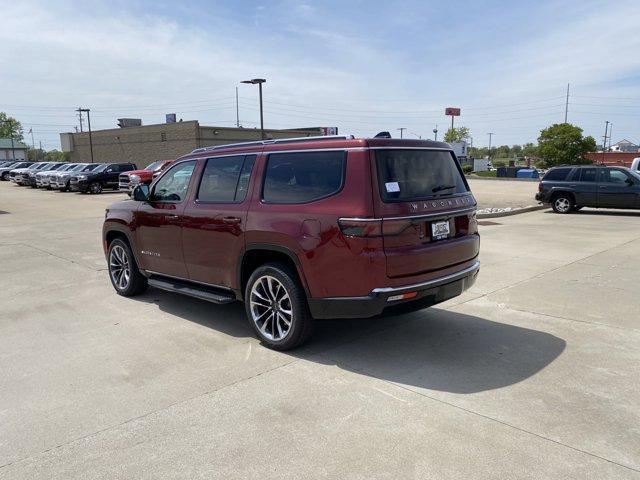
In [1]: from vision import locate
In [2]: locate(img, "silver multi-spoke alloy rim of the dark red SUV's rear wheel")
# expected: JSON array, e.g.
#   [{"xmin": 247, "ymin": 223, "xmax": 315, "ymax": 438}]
[{"xmin": 249, "ymin": 275, "xmax": 293, "ymax": 341}]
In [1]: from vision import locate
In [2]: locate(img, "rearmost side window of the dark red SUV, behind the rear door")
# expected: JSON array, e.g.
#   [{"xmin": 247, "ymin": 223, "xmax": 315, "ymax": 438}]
[{"xmin": 262, "ymin": 151, "xmax": 346, "ymax": 203}]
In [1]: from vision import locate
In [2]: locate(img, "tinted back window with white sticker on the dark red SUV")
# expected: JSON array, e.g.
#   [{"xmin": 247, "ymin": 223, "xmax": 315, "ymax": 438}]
[{"xmin": 375, "ymin": 149, "xmax": 468, "ymax": 202}]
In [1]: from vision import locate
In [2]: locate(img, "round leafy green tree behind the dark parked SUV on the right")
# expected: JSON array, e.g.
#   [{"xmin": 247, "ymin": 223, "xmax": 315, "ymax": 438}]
[{"xmin": 538, "ymin": 123, "xmax": 596, "ymax": 167}]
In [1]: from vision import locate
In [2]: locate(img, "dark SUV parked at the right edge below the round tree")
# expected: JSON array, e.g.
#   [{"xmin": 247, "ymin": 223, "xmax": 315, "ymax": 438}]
[{"xmin": 536, "ymin": 165, "xmax": 640, "ymax": 214}]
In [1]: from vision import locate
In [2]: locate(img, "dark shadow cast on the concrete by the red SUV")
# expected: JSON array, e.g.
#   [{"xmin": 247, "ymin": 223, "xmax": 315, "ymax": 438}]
[{"xmin": 131, "ymin": 289, "xmax": 566, "ymax": 394}]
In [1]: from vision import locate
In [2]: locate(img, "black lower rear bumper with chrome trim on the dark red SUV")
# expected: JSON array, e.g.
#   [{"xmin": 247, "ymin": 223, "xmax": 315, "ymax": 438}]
[{"xmin": 309, "ymin": 262, "xmax": 480, "ymax": 318}]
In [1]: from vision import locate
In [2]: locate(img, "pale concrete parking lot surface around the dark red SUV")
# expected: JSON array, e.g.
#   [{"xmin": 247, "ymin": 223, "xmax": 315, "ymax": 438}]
[{"xmin": 0, "ymin": 182, "xmax": 640, "ymax": 480}]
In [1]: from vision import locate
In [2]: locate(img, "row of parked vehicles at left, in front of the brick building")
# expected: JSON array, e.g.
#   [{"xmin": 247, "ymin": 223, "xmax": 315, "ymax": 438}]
[{"xmin": 0, "ymin": 162, "xmax": 137, "ymax": 194}]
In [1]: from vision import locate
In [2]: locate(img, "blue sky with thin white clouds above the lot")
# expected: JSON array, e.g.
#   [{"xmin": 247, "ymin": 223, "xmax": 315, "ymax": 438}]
[{"xmin": 0, "ymin": 0, "xmax": 640, "ymax": 149}]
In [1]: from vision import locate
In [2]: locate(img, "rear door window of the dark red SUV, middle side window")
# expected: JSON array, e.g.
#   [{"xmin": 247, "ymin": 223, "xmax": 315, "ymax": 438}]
[{"xmin": 196, "ymin": 155, "xmax": 256, "ymax": 203}]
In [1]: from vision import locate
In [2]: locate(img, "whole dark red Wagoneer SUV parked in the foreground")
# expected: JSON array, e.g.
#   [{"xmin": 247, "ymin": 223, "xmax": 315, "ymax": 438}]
[{"xmin": 103, "ymin": 137, "xmax": 480, "ymax": 350}]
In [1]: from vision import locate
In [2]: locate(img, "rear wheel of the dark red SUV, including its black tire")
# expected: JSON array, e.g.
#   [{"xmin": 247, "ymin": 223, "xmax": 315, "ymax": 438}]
[{"xmin": 244, "ymin": 263, "xmax": 315, "ymax": 351}]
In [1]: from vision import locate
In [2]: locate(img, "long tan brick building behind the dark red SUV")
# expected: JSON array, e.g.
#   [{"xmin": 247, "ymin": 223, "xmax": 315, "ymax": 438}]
[{"xmin": 60, "ymin": 120, "xmax": 324, "ymax": 168}]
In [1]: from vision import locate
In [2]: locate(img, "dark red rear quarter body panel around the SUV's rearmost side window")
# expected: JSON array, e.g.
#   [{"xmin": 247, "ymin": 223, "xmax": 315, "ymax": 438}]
[{"xmin": 246, "ymin": 148, "xmax": 384, "ymax": 297}]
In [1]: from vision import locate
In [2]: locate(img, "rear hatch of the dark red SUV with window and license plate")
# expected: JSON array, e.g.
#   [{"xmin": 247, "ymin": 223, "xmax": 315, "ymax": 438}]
[{"xmin": 371, "ymin": 146, "xmax": 479, "ymax": 278}]
